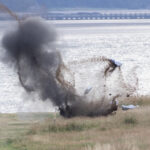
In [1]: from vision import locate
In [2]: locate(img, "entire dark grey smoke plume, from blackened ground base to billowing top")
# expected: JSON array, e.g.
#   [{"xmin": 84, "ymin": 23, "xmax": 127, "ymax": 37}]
[{"xmin": 2, "ymin": 18, "xmax": 116, "ymax": 117}]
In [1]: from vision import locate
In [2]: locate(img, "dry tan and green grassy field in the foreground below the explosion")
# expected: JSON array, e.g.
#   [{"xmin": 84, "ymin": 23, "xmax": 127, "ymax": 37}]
[{"xmin": 0, "ymin": 97, "xmax": 150, "ymax": 150}]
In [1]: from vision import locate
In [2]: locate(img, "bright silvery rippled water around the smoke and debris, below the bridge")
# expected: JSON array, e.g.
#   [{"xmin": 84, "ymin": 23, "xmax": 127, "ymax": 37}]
[{"xmin": 0, "ymin": 20, "xmax": 150, "ymax": 113}]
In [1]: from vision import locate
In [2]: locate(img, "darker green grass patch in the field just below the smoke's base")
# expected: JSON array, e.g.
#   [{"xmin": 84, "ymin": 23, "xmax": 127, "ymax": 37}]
[{"xmin": 28, "ymin": 118, "xmax": 96, "ymax": 134}]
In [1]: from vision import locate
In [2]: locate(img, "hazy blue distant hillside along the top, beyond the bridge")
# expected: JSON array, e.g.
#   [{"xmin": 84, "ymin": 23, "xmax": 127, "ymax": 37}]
[{"xmin": 0, "ymin": 0, "xmax": 150, "ymax": 11}]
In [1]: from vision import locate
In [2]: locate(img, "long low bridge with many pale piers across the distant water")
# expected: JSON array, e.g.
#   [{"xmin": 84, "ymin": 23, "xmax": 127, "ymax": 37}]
[{"xmin": 41, "ymin": 12, "xmax": 150, "ymax": 20}]
